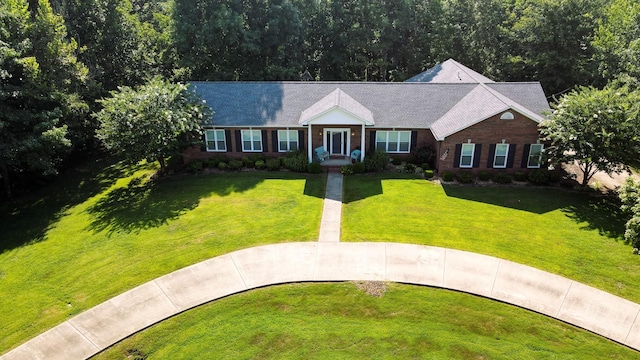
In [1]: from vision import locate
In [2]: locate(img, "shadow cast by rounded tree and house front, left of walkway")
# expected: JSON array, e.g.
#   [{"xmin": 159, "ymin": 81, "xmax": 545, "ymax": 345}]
[{"xmin": 88, "ymin": 172, "xmax": 324, "ymax": 234}]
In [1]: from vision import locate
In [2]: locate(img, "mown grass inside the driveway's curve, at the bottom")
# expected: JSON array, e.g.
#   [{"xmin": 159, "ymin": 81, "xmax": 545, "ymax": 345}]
[{"xmin": 96, "ymin": 283, "xmax": 638, "ymax": 360}]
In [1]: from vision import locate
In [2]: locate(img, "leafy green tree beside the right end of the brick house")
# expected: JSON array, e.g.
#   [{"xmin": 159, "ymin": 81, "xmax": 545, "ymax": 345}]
[{"xmin": 541, "ymin": 85, "xmax": 640, "ymax": 186}]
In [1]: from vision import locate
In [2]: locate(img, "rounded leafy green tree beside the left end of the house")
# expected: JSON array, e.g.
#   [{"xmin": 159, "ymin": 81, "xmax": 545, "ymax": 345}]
[{"xmin": 95, "ymin": 77, "xmax": 211, "ymax": 172}]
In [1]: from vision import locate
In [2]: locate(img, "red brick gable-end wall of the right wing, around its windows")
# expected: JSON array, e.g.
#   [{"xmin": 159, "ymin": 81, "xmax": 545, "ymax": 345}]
[{"xmin": 436, "ymin": 111, "xmax": 539, "ymax": 174}]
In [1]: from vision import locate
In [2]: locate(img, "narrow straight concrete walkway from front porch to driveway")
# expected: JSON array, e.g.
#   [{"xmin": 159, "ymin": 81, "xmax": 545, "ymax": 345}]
[{"xmin": 318, "ymin": 172, "xmax": 343, "ymax": 242}]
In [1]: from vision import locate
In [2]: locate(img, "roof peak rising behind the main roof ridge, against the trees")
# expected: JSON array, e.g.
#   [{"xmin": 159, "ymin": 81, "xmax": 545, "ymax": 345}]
[{"xmin": 405, "ymin": 59, "xmax": 494, "ymax": 84}]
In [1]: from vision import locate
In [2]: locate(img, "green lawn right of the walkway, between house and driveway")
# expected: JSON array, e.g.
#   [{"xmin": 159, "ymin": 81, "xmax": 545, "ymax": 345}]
[{"xmin": 342, "ymin": 176, "xmax": 640, "ymax": 302}]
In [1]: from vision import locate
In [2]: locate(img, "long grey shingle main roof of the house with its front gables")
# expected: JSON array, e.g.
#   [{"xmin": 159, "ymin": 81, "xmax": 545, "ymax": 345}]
[{"xmin": 191, "ymin": 61, "xmax": 549, "ymax": 140}]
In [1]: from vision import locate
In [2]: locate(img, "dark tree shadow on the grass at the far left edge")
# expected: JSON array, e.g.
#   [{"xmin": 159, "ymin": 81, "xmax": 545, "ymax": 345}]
[{"xmin": 0, "ymin": 154, "xmax": 146, "ymax": 253}]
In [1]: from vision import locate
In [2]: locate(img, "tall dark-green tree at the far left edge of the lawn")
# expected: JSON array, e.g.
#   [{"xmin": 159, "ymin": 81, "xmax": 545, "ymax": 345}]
[{"xmin": 0, "ymin": 0, "xmax": 87, "ymax": 197}]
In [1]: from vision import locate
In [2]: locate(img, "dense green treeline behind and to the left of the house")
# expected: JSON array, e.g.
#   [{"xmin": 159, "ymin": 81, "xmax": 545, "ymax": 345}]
[{"xmin": 0, "ymin": 0, "xmax": 640, "ymax": 198}]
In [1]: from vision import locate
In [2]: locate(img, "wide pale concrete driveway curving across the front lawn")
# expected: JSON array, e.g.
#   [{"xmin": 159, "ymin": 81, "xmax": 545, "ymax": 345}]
[{"xmin": 0, "ymin": 242, "xmax": 640, "ymax": 360}]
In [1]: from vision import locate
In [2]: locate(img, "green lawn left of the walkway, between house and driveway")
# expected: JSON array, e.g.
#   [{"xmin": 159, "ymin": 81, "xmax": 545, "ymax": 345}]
[{"xmin": 0, "ymin": 161, "xmax": 325, "ymax": 353}]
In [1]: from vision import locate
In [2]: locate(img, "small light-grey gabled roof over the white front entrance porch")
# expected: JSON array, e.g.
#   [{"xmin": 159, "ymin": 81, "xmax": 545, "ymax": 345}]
[{"xmin": 299, "ymin": 88, "xmax": 374, "ymax": 125}]
